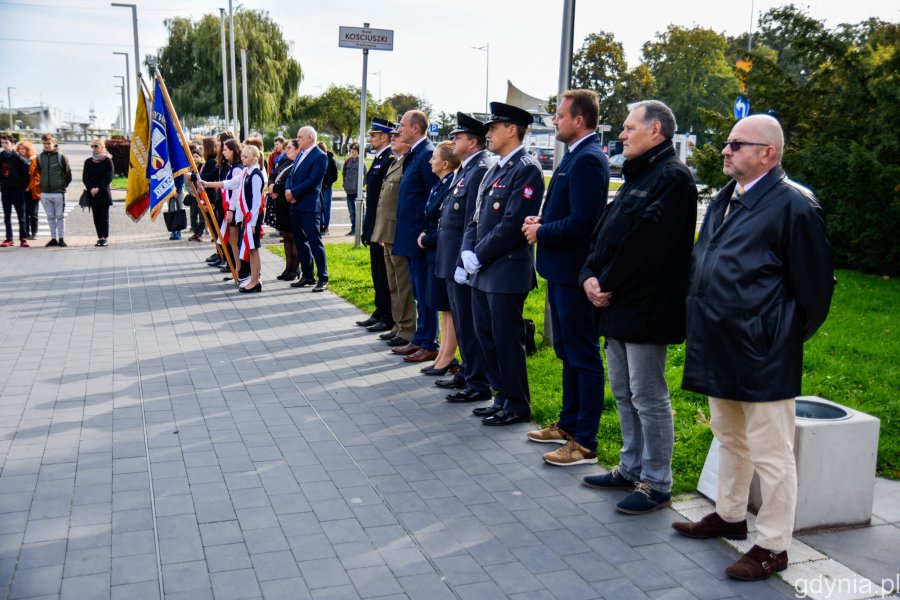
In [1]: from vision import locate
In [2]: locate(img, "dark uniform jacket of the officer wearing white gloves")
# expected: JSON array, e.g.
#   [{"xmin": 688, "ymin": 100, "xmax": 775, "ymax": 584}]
[{"xmin": 459, "ymin": 148, "xmax": 544, "ymax": 294}]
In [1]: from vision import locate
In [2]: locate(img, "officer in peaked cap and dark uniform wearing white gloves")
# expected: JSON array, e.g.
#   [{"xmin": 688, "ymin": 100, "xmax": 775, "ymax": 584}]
[{"xmin": 455, "ymin": 102, "xmax": 544, "ymax": 425}]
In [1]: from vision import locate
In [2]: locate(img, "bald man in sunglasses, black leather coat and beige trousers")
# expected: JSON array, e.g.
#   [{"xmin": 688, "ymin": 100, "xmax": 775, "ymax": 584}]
[{"xmin": 672, "ymin": 115, "xmax": 834, "ymax": 581}]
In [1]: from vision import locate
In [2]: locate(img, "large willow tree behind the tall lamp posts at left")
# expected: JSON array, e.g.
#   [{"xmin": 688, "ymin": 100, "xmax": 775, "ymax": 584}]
[{"xmin": 149, "ymin": 10, "xmax": 302, "ymax": 134}]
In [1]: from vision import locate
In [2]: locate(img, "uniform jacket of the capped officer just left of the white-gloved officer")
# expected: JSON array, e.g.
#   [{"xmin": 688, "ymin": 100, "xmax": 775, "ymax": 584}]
[{"xmin": 434, "ymin": 150, "xmax": 493, "ymax": 279}]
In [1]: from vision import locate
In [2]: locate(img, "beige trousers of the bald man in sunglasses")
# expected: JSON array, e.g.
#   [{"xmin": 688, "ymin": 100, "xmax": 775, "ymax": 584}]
[{"xmin": 709, "ymin": 397, "xmax": 797, "ymax": 552}]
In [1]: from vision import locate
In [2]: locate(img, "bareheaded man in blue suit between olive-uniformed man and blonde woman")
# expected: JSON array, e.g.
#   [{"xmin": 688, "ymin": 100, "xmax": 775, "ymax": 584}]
[{"xmin": 393, "ymin": 110, "xmax": 440, "ymax": 362}]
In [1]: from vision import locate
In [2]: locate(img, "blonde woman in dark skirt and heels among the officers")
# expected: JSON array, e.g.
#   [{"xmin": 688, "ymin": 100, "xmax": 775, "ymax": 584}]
[{"xmin": 418, "ymin": 141, "xmax": 460, "ymax": 375}]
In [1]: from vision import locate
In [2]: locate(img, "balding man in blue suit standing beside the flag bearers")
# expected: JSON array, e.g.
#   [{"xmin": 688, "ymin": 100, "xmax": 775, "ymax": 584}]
[{"xmin": 284, "ymin": 125, "xmax": 328, "ymax": 292}]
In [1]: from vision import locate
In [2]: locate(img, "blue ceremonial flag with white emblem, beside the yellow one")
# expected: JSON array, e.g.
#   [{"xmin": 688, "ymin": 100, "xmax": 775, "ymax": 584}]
[{"xmin": 147, "ymin": 79, "xmax": 191, "ymax": 221}]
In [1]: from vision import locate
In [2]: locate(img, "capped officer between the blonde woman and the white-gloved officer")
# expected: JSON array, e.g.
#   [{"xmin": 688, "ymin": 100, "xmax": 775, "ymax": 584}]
[{"xmin": 434, "ymin": 112, "xmax": 496, "ymax": 402}]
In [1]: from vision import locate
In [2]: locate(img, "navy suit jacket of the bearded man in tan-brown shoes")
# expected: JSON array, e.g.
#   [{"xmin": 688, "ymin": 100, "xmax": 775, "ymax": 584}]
[{"xmin": 536, "ymin": 135, "xmax": 609, "ymax": 285}]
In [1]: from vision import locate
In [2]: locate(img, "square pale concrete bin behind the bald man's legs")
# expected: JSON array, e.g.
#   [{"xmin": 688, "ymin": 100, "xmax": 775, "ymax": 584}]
[{"xmin": 697, "ymin": 396, "xmax": 881, "ymax": 532}]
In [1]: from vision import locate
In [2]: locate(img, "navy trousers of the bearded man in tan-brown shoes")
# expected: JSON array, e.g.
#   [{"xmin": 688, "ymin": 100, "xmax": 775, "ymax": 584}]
[{"xmin": 547, "ymin": 281, "xmax": 603, "ymax": 450}]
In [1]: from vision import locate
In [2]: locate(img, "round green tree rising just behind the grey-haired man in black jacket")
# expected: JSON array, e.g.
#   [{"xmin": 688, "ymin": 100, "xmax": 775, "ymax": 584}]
[{"xmin": 643, "ymin": 25, "xmax": 739, "ymax": 134}]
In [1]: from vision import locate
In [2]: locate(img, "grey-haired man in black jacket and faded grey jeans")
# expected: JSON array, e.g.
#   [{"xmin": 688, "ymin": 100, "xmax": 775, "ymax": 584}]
[{"xmin": 578, "ymin": 100, "xmax": 697, "ymax": 514}]
